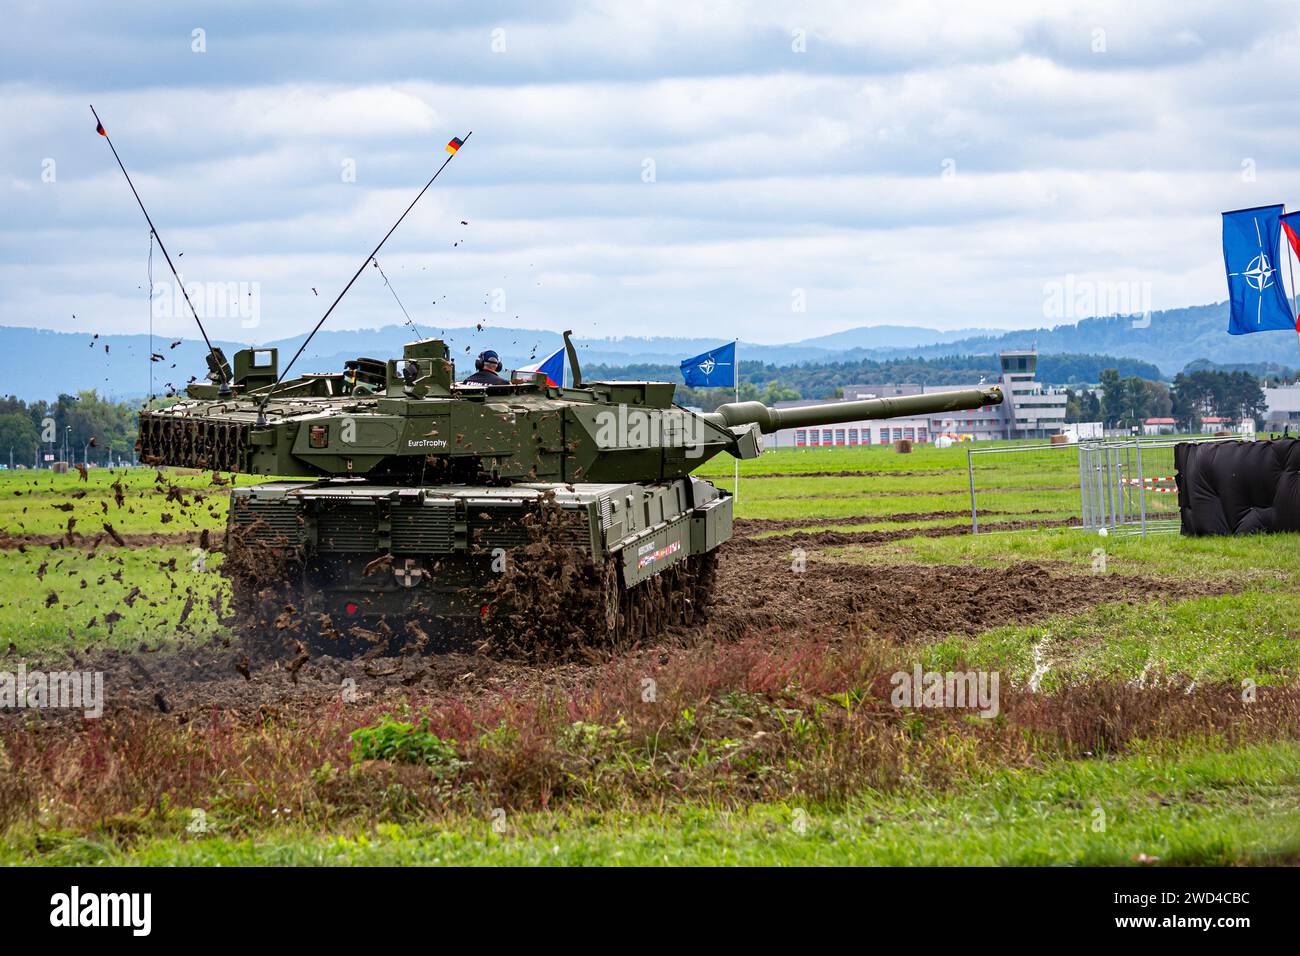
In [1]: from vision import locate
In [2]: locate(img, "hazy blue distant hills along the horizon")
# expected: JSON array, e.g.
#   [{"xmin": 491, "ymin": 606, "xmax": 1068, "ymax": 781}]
[{"xmin": 0, "ymin": 302, "xmax": 1300, "ymax": 399}]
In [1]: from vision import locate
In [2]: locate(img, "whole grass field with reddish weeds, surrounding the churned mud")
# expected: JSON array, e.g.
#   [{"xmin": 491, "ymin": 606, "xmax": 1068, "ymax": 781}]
[{"xmin": 0, "ymin": 447, "xmax": 1300, "ymax": 865}]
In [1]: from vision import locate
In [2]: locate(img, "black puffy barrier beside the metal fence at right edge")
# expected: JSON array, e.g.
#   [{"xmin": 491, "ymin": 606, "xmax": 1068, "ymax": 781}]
[{"xmin": 1174, "ymin": 438, "xmax": 1300, "ymax": 535}]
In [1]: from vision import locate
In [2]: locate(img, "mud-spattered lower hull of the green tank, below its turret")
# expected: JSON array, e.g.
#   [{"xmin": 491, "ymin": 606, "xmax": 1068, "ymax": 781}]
[{"xmin": 225, "ymin": 477, "xmax": 732, "ymax": 647}]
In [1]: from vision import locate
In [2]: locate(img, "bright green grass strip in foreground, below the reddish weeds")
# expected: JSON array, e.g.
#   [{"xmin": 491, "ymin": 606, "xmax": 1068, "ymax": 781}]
[{"xmin": 0, "ymin": 744, "xmax": 1300, "ymax": 866}]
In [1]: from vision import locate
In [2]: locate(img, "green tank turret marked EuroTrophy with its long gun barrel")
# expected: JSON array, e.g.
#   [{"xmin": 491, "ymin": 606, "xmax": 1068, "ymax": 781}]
[{"xmin": 140, "ymin": 339, "xmax": 1002, "ymax": 484}]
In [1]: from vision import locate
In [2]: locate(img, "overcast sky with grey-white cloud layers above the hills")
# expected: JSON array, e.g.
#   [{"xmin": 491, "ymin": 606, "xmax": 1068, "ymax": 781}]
[{"xmin": 0, "ymin": 0, "xmax": 1300, "ymax": 343}]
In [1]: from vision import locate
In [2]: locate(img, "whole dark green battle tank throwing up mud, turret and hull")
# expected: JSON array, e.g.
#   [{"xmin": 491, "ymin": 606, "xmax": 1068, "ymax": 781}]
[{"xmin": 138, "ymin": 333, "xmax": 1002, "ymax": 656}]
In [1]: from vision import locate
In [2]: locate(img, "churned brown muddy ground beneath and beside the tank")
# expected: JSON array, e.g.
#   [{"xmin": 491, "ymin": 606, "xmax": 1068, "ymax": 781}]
[{"xmin": 0, "ymin": 515, "xmax": 1223, "ymax": 721}]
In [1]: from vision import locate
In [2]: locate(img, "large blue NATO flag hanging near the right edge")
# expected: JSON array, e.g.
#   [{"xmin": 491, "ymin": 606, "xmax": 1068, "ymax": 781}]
[{"xmin": 1223, "ymin": 204, "xmax": 1296, "ymax": 336}]
